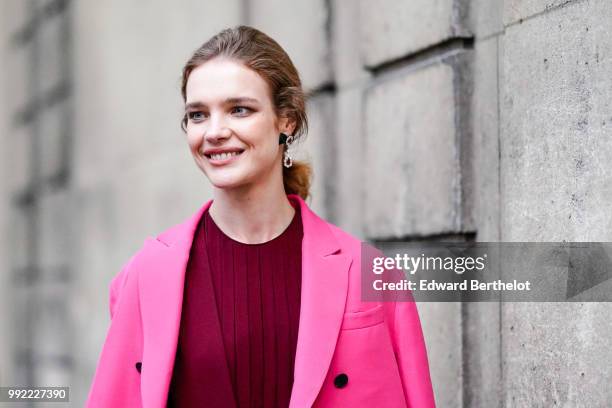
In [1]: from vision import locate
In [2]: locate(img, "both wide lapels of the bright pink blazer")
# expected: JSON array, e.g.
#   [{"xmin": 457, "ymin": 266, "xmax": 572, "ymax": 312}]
[{"xmin": 133, "ymin": 194, "xmax": 351, "ymax": 408}]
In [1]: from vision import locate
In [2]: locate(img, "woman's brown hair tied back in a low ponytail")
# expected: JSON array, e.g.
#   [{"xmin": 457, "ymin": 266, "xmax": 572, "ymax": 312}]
[{"xmin": 181, "ymin": 25, "xmax": 312, "ymax": 200}]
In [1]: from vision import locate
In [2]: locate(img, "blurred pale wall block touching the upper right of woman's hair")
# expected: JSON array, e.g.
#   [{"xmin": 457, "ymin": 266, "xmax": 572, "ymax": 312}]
[{"xmin": 247, "ymin": 0, "xmax": 332, "ymax": 90}]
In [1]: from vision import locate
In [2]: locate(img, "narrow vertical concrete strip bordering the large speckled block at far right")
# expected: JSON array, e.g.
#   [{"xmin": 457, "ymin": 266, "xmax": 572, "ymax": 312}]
[{"xmin": 470, "ymin": 37, "xmax": 500, "ymax": 241}]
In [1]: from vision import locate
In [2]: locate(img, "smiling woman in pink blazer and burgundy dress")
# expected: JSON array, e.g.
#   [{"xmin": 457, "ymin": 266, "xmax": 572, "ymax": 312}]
[{"xmin": 88, "ymin": 26, "xmax": 434, "ymax": 407}]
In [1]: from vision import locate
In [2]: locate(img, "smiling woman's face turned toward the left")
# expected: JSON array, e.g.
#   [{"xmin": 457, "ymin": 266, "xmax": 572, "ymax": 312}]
[{"xmin": 185, "ymin": 58, "xmax": 290, "ymax": 189}]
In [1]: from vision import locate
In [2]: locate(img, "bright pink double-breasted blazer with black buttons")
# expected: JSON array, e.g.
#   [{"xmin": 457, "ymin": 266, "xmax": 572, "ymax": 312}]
[{"xmin": 87, "ymin": 195, "xmax": 435, "ymax": 408}]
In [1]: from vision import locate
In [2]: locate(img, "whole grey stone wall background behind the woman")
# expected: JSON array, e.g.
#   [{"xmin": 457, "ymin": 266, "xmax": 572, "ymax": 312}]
[{"xmin": 0, "ymin": 0, "xmax": 612, "ymax": 407}]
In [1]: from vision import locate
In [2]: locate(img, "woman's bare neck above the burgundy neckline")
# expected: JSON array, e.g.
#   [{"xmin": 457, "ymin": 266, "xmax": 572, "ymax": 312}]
[{"xmin": 208, "ymin": 178, "xmax": 295, "ymax": 244}]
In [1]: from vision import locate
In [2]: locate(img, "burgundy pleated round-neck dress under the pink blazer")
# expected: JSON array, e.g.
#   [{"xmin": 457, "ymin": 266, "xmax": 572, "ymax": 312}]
[{"xmin": 168, "ymin": 206, "xmax": 303, "ymax": 408}]
